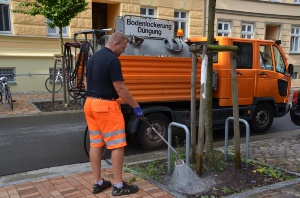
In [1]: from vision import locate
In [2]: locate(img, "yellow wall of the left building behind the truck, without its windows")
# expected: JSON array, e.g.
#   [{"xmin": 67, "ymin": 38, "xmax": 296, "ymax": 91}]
[{"xmin": 0, "ymin": 0, "xmax": 203, "ymax": 92}]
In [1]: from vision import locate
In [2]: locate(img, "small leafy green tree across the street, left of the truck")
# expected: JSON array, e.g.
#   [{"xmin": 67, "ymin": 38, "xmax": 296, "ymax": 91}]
[{"xmin": 12, "ymin": 0, "xmax": 88, "ymax": 104}]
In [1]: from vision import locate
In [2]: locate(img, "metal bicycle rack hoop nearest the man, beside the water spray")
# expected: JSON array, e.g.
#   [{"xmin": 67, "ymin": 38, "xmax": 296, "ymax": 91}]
[{"xmin": 168, "ymin": 122, "xmax": 190, "ymax": 173}]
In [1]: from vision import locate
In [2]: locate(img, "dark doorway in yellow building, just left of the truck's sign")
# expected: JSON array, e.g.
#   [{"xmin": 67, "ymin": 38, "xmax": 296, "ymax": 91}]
[{"xmin": 92, "ymin": 3, "xmax": 107, "ymax": 29}]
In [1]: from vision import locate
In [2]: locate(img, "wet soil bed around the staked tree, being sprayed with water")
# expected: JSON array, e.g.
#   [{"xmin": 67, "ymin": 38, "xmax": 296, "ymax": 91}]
[{"xmin": 128, "ymin": 153, "xmax": 296, "ymax": 198}]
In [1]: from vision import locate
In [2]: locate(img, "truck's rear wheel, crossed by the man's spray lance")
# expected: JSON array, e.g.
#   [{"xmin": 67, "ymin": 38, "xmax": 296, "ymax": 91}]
[{"xmin": 137, "ymin": 113, "xmax": 170, "ymax": 150}]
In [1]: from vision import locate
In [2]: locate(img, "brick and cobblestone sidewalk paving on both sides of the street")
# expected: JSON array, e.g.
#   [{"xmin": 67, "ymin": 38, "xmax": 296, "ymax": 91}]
[{"xmin": 0, "ymin": 80, "xmax": 300, "ymax": 198}]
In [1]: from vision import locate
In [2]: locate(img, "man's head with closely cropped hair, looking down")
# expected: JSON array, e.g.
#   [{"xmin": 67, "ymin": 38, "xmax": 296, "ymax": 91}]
[{"xmin": 105, "ymin": 32, "xmax": 129, "ymax": 56}]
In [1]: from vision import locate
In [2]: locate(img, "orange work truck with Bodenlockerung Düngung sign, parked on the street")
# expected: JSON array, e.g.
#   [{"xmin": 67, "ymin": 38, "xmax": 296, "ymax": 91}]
[{"xmin": 74, "ymin": 16, "xmax": 293, "ymax": 149}]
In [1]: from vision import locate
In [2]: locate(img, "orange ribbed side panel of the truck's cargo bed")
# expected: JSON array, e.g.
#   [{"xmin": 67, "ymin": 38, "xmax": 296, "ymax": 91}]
[{"xmin": 119, "ymin": 55, "xmax": 201, "ymax": 102}]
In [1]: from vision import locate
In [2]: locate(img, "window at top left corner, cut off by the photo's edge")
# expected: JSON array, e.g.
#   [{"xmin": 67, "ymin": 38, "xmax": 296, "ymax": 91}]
[{"xmin": 0, "ymin": 0, "xmax": 11, "ymax": 33}]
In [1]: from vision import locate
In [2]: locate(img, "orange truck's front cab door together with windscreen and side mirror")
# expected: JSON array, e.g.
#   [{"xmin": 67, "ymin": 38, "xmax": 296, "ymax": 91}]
[{"xmin": 255, "ymin": 44, "xmax": 289, "ymax": 103}]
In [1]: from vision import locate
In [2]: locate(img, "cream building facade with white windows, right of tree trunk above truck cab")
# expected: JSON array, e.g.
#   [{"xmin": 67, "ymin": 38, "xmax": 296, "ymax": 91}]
[{"xmin": 215, "ymin": 0, "xmax": 300, "ymax": 78}]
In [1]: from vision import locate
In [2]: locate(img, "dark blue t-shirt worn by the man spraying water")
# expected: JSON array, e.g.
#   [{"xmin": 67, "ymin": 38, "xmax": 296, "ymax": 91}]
[{"xmin": 86, "ymin": 47, "xmax": 124, "ymax": 99}]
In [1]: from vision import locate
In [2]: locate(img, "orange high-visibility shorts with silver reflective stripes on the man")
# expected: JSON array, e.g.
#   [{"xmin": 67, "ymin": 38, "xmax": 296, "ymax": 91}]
[{"xmin": 84, "ymin": 98, "xmax": 127, "ymax": 149}]
